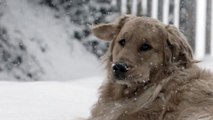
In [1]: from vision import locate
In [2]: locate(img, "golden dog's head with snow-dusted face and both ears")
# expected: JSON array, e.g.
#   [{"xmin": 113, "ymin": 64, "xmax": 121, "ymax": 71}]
[{"xmin": 92, "ymin": 16, "xmax": 193, "ymax": 84}]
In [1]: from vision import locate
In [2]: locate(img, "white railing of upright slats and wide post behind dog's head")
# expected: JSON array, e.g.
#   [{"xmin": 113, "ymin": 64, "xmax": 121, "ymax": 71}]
[{"xmin": 112, "ymin": 0, "xmax": 213, "ymax": 59}]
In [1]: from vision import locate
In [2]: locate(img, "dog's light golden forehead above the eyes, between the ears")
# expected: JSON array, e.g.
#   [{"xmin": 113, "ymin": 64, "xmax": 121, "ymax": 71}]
[{"xmin": 119, "ymin": 17, "xmax": 165, "ymax": 42}]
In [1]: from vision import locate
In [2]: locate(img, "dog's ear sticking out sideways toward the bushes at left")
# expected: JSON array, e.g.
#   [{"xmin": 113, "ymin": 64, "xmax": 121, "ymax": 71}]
[{"xmin": 92, "ymin": 15, "xmax": 135, "ymax": 41}]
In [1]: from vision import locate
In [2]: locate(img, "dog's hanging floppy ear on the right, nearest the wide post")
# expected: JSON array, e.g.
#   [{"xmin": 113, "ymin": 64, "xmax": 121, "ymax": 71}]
[{"xmin": 164, "ymin": 25, "xmax": 194, "ymax": 67}]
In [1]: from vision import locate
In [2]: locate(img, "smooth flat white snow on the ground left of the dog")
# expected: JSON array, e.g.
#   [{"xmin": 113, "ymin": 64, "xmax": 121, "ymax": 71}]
[{"xmin": 0, "ymin": 77, "xmax": 103, "ymax": 120}]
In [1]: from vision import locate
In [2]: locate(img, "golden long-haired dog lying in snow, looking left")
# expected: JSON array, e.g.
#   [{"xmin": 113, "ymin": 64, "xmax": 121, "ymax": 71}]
[{"xmin": 88, "ymin": 15, "xmax": 213, "ymax": 120}]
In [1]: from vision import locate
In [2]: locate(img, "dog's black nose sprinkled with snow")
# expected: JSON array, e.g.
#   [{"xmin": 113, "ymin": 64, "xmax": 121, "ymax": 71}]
[{"xmin": 112, "ymin": 63, "xmax": 128, "ymax": 76}]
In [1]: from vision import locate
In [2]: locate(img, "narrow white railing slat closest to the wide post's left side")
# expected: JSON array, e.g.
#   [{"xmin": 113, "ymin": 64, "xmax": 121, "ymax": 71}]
[{"xmin": 174, "ymin": 0, "xmax": 180, "ymax": 27}]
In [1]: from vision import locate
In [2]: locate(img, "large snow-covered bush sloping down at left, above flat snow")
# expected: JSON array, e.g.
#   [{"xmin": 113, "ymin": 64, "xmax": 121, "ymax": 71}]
[{"xmin": 0, "ymin": 0, "xmax": 100, "ymax": 80}]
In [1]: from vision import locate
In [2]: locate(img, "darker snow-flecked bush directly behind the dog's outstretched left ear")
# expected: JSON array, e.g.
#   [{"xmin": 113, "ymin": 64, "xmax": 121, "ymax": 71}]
[{"xmin": 39, "ymin": 0, "xmax": 118, "ymax": 57}]
